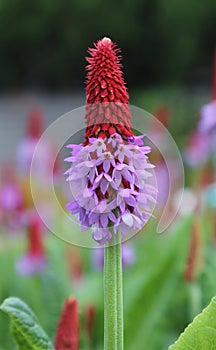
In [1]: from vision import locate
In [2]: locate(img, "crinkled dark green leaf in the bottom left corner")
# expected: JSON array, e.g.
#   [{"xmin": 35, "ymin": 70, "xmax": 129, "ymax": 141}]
[{"xmin": 0, "ymin": 297, "xmax": 53, "ymax": 350}]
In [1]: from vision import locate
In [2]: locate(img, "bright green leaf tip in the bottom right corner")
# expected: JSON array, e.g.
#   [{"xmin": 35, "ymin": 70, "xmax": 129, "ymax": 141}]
[{"xmin": 169, "ymin": 297, "xmax": 216, "ymax": 350}]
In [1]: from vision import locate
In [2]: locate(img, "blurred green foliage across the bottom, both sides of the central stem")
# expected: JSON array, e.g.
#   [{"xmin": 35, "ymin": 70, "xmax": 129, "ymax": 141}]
[{"xmin": 0, "ymin": 209, "xmax": 216, "ymax": 350}]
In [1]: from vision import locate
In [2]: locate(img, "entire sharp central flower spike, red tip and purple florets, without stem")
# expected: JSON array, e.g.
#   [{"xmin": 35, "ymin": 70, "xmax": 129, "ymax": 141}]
[{"xmin": 66, "ymin": 38, "xmax": 157, "ymax": 244}]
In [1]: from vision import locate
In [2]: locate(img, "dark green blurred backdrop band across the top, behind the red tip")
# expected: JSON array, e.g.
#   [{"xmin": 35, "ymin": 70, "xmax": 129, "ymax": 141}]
[{"xmin": 0, "ymin": 0, "xmax": 216, "ymax": 90}]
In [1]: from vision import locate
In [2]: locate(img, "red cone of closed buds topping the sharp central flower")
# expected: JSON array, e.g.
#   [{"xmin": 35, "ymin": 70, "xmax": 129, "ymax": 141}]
[{"xmin": 85, "ymin": 38, "xmax": 132, "ymax": 138}]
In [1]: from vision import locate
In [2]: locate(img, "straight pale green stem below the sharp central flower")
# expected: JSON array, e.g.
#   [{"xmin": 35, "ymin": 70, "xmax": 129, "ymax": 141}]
[{"xmin": 104, "ymin": 235, "xmax": 124, "ymax": 350}]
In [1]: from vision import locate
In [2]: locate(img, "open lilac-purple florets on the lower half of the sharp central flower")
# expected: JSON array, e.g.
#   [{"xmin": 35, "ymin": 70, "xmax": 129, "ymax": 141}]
[{"xmin": 66, "ymin": 134, "xmax": 157, "ymax": 245}]
